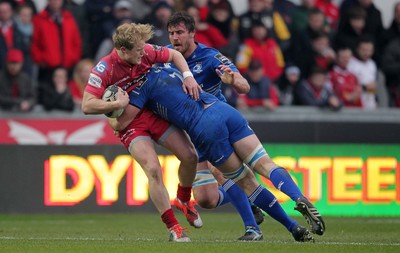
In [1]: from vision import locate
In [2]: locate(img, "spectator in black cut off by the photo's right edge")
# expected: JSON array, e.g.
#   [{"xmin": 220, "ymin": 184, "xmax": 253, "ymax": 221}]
[{"xmin": 381, "ymin": 35, "xmax": 400, "ymax": 107}]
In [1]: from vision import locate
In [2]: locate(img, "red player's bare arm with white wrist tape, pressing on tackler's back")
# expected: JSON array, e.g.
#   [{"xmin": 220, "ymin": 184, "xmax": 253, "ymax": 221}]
[{"xmin": 168, "ymin": 48, "xmax": 202, "ymax": 100}]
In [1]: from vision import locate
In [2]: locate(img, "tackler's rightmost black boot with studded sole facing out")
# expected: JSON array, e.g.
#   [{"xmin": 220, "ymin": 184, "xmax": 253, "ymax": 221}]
[{"xmin": 294, "ymin": 196, "xmax": 325, "ymax": 235}]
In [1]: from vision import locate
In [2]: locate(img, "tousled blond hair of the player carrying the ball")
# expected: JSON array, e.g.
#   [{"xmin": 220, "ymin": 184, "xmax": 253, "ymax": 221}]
[{"xmin": 113, "ymin": 23, "xmax": 154, "ymax": 50}]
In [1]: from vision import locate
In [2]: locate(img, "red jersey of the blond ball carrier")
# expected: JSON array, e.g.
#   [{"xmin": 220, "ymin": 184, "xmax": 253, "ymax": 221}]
[{"xmin": 85, "ymin": 44, "xmax": 169, "ymax": 98}]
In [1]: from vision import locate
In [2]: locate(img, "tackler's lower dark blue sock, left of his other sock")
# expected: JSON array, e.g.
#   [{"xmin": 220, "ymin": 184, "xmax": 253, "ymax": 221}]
[{"xmin": 249, "ymin": 185, "xmax": 298, "ymax": 232}]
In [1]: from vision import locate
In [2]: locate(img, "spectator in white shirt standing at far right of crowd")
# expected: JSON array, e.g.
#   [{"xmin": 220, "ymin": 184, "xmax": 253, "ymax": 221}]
[{"xmin": 348, "ymin": 37, "xmax": 378, "ymax": 109}]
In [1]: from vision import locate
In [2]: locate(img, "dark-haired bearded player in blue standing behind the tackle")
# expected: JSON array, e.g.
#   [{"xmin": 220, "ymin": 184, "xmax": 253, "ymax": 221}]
[{"xmin": 161, "ymin": 12, "xmax": 324, "ymax": 241}]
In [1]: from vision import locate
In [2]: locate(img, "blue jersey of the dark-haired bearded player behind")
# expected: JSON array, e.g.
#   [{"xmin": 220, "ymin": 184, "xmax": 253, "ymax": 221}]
[{"xmin": 164, "ymin": 43, "xmax": 239, "ymax": 102}]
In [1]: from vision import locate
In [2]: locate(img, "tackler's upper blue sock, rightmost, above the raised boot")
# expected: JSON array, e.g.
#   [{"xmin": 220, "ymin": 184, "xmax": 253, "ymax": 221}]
[{"xmin": 269, "ymin": 167, "xmax": 303, "ymax": 201}]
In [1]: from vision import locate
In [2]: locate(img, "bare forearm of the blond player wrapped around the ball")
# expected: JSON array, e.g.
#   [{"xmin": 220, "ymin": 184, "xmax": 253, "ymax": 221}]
[{"xmin": 82, "ymin": 88, "xmax": 129, "ymax": 114}]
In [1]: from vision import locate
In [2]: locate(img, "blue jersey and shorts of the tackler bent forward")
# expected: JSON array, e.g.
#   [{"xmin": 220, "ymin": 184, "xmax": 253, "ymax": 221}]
[{"xmin": 129, "ymin": 68, "xmax": 254, "ymax": 166}]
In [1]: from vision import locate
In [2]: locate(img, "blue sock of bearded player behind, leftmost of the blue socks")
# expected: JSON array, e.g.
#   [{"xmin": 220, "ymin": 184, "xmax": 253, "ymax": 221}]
[{"xmin": 218, "ymin": 179, "xmax": 260, "ymax": 231}]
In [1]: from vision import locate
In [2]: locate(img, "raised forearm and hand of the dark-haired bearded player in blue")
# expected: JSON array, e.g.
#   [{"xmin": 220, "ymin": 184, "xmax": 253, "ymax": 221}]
[{"xmin": 215, "ymin": 65, "xmax": 250, "ymax": 94}]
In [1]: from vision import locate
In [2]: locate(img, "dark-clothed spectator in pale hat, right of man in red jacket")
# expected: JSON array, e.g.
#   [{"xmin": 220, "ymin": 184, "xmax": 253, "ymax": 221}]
[{"xmin": 277, "ymin": 65, "xmax": 301, "ymax": 106}]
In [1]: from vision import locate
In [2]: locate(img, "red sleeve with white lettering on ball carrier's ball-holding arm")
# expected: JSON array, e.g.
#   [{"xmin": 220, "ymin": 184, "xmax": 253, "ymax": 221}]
[{"xmin": 85, "ymin": 61, "xmax": 110, "ymax": 98}]
